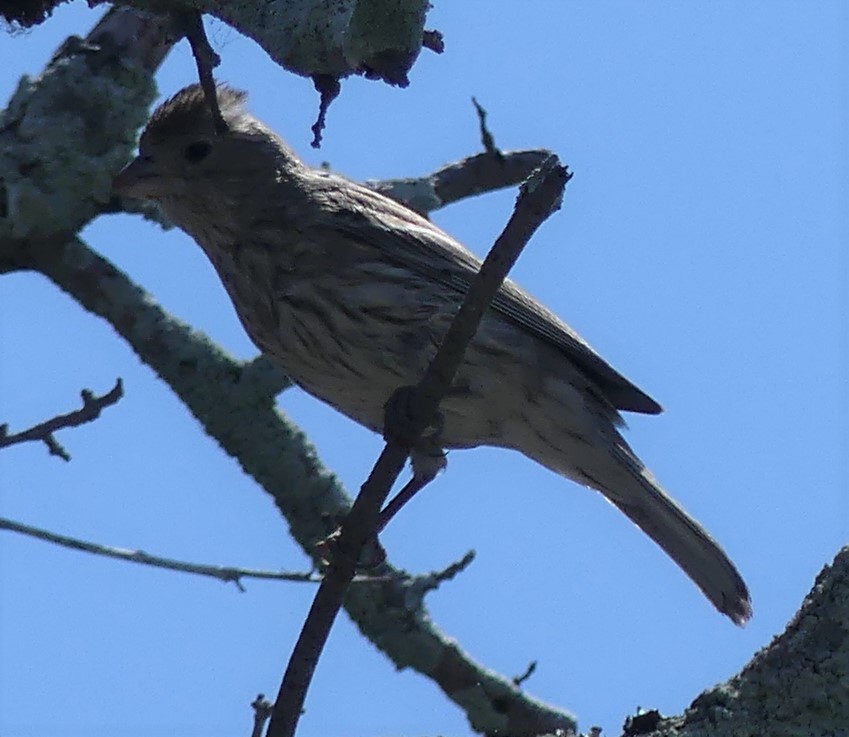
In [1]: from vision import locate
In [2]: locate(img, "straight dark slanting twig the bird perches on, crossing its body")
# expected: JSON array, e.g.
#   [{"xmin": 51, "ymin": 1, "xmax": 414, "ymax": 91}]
[{"xmin": 267, "ymin": 155, "xmax": 570, "ymax": 737}]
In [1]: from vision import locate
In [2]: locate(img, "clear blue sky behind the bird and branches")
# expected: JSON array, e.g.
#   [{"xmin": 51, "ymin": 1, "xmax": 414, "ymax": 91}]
[{"xmin": 0, "ymin": 0, "xmax": 849, "ymax": 737}]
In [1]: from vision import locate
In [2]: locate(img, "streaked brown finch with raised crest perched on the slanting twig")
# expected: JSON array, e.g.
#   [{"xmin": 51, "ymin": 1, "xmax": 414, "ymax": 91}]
[{"xmin": 115, "ymin": 85, "xmax": 751, "ymax": 624}]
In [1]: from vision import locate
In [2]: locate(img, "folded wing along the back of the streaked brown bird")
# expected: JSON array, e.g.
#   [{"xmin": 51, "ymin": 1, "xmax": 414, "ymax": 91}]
[{"xmin": 304, "ymin": 172, "xmax": 662, "ymax": 414}]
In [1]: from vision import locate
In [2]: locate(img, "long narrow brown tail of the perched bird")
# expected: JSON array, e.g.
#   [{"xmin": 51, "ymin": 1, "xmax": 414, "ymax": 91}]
[{"xmin": 546, "ymin": 444, "xmax": 752, "ymax": 625}]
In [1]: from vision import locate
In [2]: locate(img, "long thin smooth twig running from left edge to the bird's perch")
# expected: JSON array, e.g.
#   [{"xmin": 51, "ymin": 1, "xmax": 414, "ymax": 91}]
[{"xmin": 0, "ymin": 517, "xmax": 322, "ymax": 591}]
